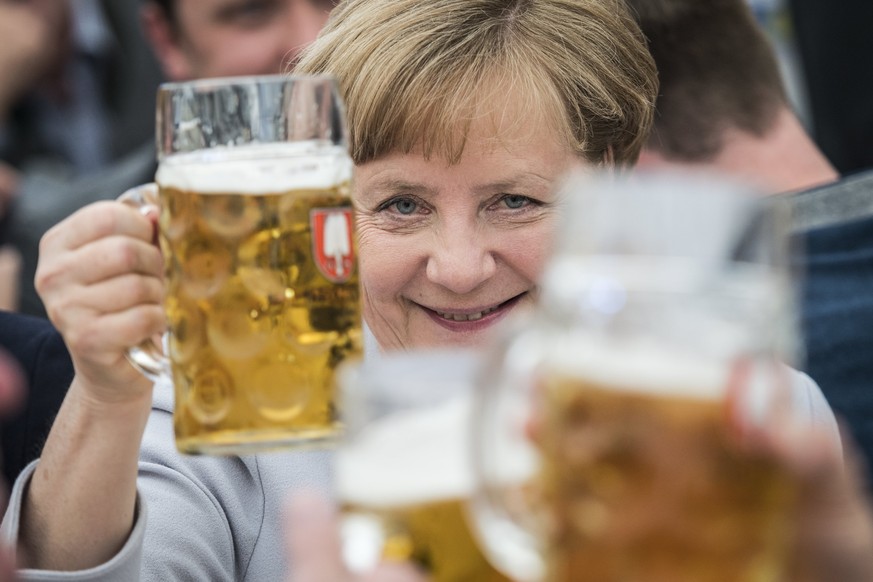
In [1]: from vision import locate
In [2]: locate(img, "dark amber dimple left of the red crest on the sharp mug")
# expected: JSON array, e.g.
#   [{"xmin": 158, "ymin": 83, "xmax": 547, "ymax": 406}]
[{"xmin": 237, "ymin": 229, "xmax": 307, "ymax": 303}]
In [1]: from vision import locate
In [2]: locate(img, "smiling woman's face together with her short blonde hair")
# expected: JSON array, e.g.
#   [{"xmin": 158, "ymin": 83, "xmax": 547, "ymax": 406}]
[{"xmin": 297, "ymin": 0, "xmax": 656, "ymax": 349}]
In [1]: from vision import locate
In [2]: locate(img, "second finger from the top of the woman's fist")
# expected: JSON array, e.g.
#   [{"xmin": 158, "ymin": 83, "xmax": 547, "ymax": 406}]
[{"xmin": 36, "ymin": 236, "xmax": 164, "ymax": 295}]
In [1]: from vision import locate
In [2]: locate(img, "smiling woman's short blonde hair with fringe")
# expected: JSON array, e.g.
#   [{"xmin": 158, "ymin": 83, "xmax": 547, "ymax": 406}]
[{"xmin": 295, "ymin": 0, "xmax": 657, "ymax": 165}]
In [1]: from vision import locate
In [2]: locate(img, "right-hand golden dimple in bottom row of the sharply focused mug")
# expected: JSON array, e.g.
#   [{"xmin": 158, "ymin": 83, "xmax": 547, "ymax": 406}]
[{"xmin": 246, "ymin": 352, "xmax": 321, "ymax": 422}]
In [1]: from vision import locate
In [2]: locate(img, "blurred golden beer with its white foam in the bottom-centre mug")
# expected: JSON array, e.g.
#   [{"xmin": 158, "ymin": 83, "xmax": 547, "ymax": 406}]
[{"xmin": 337, "ymin": 394, "xmax": 509, "ymax": 582}]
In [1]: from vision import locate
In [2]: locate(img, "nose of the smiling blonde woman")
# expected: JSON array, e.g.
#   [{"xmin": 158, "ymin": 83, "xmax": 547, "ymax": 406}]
[{"xmin": 427, "ymin": 226, "xmax": 497, "ymax": 295}]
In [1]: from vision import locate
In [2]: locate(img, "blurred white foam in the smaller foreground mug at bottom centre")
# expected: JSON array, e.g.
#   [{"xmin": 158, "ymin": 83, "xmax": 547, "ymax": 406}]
[{"xmin": 336, "ymin": 395, "xmax": 474, "ymax": 508}]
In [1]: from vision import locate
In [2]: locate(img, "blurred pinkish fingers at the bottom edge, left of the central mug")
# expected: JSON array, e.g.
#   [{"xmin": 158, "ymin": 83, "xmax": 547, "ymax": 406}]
[{"xmin": 285, "ymin": 493, "xmax": 427, "ymax": 582}]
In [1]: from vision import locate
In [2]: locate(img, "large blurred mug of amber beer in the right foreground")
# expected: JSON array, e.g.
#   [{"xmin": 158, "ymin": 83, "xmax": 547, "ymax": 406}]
[{"xmin": 473, "ymin": 174, "xmax": 795, "ymax": 582}]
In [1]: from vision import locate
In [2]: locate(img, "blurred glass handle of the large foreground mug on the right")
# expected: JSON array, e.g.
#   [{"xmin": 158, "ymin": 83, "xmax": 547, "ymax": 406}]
[{"xmin": 468, "ymin": 328, "xmax": 546, "ymax": 582}]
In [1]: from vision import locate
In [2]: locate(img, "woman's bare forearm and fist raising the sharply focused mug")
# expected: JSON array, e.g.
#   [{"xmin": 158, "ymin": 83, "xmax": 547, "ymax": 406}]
[{"xmin": 19, "ymin": 202, "xmax": 165, "ymax": 570}]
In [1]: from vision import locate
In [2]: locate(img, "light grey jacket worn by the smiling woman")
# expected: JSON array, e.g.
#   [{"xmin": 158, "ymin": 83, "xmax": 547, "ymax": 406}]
[{"xmin": 3, "ymin": 372, "xmax": 839, "ymax": 582}]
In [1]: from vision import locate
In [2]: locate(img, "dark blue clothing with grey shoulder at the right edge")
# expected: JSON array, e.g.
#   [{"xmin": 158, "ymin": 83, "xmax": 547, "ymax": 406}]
[{"xmin": 795, "ymin": 172, "xmax": 873, "ymax": 491}]
